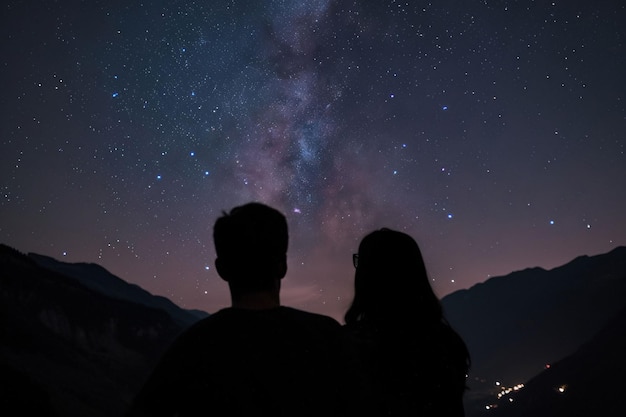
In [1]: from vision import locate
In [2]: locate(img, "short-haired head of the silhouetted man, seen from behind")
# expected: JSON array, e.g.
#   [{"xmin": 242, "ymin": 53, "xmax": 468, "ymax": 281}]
[{"xmin": 213, "ymin": 203, "xmax": 289, "ymax": 294}]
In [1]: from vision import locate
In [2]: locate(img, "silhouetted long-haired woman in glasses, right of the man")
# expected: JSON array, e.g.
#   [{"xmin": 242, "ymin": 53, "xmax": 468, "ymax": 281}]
[{"xmin": 345, "ymin": 229, "xmax": 470, "ymax": 416}]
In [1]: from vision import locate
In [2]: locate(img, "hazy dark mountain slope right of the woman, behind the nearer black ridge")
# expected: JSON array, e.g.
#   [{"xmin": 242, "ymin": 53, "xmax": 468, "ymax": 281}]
[{"xmin": 442, "ymin": 247, "xmax": 626, "ymax": 416}]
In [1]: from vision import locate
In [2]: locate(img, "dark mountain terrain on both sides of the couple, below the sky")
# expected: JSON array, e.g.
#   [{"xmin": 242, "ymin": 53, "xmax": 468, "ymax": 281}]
[{"xmin": 0, "ymin": 245, "xmax": 626, "ymax": 417}]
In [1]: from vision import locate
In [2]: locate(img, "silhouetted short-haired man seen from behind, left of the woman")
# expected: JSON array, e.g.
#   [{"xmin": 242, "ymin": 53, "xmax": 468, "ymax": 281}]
[{"xmin": 129, "ymin": 203, "xmax": 342, "ymax": 417}]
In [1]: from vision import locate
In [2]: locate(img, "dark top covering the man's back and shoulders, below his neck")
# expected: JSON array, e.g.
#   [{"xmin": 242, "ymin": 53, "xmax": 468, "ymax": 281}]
[{"xmin": 125, "ymin": 307, "xmax": 344, "ymax": 417}]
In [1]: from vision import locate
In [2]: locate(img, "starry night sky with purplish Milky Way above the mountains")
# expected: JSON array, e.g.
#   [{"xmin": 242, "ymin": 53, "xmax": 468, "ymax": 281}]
[{"xmin": 0, "ymin": 0, "xmax": 626, "ymax": 320}]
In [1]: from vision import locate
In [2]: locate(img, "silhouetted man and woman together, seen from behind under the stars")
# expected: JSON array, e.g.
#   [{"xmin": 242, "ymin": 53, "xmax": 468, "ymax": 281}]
[{"xmin": 128, "ymin": 202, "xmax": 469, "ymax": 417}]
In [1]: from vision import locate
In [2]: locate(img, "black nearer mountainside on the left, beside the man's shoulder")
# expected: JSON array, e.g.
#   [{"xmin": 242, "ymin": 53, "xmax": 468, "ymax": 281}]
[{"xmin": 0, "ymin": 245, "xmax": 202, "ymax": 417}]
